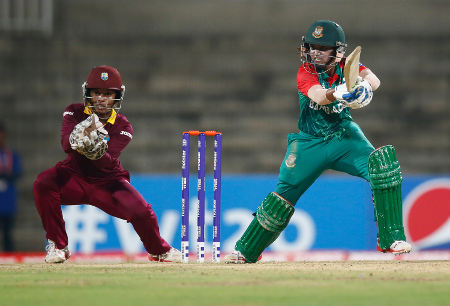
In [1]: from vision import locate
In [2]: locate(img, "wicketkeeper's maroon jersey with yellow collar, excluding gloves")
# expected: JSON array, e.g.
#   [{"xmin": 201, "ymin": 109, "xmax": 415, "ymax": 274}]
[{"xmin": 57, "ymin": 103, "xmax": 133, "ymax": 181}]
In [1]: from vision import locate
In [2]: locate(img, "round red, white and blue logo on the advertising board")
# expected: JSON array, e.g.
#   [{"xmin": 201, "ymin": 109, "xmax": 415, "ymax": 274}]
[{"xmin": 403, "ymin": 178, "xmax": 450, "ymax": 250}]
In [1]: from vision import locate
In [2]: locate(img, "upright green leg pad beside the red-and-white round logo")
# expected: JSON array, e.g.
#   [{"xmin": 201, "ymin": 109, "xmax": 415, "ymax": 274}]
[{"xmin": 369, "ymin": 145, "xmax": 406, "ymax": 250}]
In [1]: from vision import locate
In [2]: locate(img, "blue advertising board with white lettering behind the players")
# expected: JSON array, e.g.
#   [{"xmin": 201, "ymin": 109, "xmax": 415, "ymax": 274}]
[{"xmin": 63, "ymin": 175, "xmax": 450, "ymax": 253}]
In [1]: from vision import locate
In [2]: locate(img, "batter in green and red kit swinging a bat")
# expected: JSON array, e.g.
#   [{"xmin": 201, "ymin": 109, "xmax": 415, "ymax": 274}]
[{"xmin": 225, "ymin": 20, "xmax": 411, "ymax": 263}]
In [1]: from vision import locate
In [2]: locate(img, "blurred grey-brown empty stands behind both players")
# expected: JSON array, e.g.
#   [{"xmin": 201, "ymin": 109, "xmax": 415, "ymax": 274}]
[{"xmin": 0, "ymin": 0, "xmax": 450, "ymax": 250}]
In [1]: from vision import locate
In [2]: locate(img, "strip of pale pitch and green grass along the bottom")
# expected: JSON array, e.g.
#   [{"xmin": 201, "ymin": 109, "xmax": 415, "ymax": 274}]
[{"xmin": 0, "ymin": 261, "xmax": 450, "ymax": 306}]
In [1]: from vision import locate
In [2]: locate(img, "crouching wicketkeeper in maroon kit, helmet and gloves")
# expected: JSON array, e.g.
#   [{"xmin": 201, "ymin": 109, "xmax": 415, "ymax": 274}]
[{"xmin": 33, "ymin": 66, "xmax": 181, "ymax": 263}]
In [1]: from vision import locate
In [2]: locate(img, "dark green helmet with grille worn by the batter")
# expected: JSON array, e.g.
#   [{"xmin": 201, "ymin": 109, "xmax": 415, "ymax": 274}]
[{"xmin": 298, "ymin": 20, "xmax": 347, "ymax": 72}]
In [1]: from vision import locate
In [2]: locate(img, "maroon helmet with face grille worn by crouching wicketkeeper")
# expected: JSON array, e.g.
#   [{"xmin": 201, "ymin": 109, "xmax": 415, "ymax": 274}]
[{"xmin": 81, "ymin": 65, "xmax": 125, "ymax": 116}]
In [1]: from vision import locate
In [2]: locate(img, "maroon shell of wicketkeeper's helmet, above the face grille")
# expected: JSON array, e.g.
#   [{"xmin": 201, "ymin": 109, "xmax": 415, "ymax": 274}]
[{"xmin": 86, "ymin": 65, "xmax": 122, "ymax": 90}]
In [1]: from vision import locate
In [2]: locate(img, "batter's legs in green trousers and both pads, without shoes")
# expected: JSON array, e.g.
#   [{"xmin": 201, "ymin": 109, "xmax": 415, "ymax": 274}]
[{"xmin": 235, "ymin": 121, "xmax": 405, "ymax": 262}]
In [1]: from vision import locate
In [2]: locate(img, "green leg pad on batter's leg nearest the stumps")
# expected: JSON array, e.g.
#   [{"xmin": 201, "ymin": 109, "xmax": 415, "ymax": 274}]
[{"xmin": 235, "ymin": 192, "xmax": 294, "ymax": 262}]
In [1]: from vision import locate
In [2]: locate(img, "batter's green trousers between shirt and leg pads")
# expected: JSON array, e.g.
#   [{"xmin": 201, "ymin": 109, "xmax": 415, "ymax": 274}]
[{"xmin": 275, "ymin": 121, "xmax": 375, "ymax": 205}]
